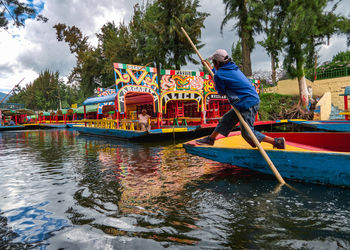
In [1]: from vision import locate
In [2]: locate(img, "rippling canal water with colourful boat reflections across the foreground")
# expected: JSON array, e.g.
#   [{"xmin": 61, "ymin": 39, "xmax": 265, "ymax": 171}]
[{"xmin": 0, "ymin": 130, "xmax": 350, "ymax": 249}]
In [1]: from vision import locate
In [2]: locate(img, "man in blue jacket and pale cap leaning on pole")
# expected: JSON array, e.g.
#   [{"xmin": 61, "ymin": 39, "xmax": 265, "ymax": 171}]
[{"xmin": 196, "ymin": 49, "xmax": 286, "ymax": 149}]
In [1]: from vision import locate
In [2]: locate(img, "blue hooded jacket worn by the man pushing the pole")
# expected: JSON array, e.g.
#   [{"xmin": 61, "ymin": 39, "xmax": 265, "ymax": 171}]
[{"xmin": 213, "ymin": 62, "xmax": 260, "ymax": 110}]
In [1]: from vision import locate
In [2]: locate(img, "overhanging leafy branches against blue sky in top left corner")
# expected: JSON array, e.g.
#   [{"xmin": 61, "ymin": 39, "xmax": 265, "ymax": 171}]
[{"xmin": 0, "ymin": 0, "xmax": 48, "ymax": 29}]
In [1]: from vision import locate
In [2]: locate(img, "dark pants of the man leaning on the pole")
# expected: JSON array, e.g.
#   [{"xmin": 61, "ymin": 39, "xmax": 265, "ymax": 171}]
[{"xmin": 215, "ymin": 105, "xmax": 265, "ymax": 147}]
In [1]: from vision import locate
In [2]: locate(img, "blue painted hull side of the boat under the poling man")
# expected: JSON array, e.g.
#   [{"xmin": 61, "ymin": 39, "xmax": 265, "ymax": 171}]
[{"xmin": 184, "ymin": 144, "xmax": 350, "ymax": 187}]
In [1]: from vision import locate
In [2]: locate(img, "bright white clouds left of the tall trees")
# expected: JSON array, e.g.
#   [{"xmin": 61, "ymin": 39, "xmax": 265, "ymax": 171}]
[{"xmin": 0, "ymin": 0, "xmax": 139, "ymax": 90}]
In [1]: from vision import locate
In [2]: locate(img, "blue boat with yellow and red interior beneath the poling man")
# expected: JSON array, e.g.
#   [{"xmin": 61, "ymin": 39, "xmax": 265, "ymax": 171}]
[{"xmin": 184, "ymin": 132, "xmax": 350, "ymax": 187}]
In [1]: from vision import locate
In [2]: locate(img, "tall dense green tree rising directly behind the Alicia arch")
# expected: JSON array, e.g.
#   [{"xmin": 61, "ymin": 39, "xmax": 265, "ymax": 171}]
[{"xmin": 144, "ymin": 0, "xmax": 208, "ymax": 69}]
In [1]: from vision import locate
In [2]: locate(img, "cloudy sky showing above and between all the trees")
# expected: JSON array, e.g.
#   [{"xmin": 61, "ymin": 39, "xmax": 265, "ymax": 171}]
[{"xmin": 0, "ymin": 0, "xmax": 350, "ymax": 93}]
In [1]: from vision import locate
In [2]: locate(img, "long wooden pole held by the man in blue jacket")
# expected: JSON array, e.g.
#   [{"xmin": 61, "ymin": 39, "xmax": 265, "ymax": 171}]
[{"xmin": 181, "ymin": 27, "xmax": 286, "ymax": 184}]
